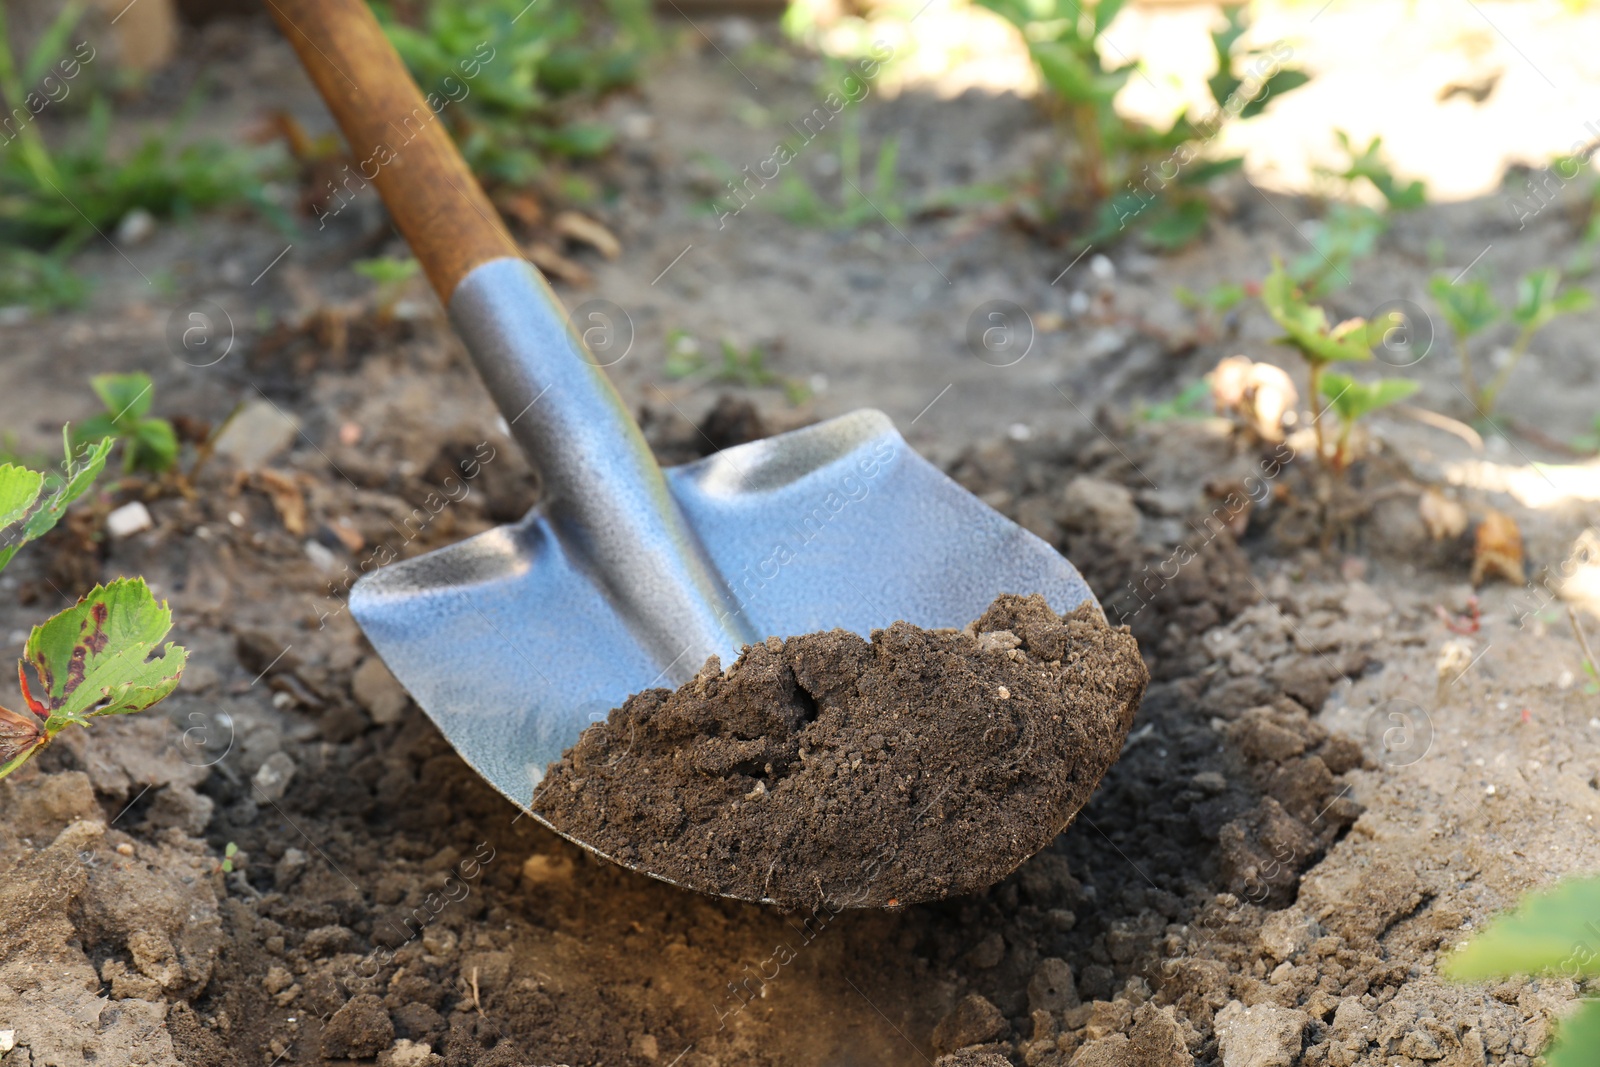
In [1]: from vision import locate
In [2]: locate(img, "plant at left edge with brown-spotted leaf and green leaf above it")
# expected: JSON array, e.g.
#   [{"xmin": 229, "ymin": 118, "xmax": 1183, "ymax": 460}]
[{"xmin": 0, "ymin": 432, "xmax": 186, "ymax": 777}]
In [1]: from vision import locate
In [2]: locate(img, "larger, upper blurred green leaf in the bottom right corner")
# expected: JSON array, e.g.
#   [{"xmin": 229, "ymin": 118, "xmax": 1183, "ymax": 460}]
[{"xmin": 1442, "ymin": 877, "xmax": 1600, "ymax": 979}]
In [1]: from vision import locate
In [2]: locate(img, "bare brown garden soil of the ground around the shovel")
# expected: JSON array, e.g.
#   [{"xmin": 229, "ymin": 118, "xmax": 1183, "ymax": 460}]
[{"xmin": 0, "ymin": 5, "xmax": 1600, "ymax": 1067}]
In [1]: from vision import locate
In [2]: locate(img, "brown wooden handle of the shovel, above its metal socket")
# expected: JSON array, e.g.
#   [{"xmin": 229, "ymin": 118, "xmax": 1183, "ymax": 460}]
[{"xmin": 266, "ymin": 0, "xmax": 522, "ymax": 306}]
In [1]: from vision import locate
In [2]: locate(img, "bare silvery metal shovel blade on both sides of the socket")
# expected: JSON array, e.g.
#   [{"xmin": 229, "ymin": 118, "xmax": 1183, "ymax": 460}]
[{"xmin": 350, "ymin": 410, "xmax": 1094, "ymax": 825}]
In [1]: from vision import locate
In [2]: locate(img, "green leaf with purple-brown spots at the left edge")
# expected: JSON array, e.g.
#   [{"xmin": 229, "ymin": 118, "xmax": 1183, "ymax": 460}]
[{"xmin": 18, "ymin": 577, "xmax": 187, "ymax": 734}]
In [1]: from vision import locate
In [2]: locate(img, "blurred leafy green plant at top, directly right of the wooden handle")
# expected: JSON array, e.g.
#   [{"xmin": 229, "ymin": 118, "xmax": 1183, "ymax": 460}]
[{"xmin": 376, "ymin": 0, "xmax": 656, "ymax": 186}]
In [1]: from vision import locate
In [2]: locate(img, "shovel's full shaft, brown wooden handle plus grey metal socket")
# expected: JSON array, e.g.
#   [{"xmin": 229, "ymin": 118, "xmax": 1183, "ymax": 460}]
[{"xmin": 266, "ymin": 0, "xmax": 752, "ymax": 685}]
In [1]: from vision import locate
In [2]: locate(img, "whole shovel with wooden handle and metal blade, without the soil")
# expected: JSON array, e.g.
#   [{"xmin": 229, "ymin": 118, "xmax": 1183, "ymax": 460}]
[{"xmin": 267, "ymin": 0, "xmax": 1094, "ymax": 902}]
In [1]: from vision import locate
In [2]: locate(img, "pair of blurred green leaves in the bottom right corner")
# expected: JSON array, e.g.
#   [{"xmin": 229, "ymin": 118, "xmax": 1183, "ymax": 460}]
[{"xmin": 1440, "ymin": 877, "xmax": 1600, "ymax": 1067}]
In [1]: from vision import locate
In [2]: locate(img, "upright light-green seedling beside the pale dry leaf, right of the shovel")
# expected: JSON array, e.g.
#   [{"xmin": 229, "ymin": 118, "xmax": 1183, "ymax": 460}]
[{"xmin": 1261, "ymin": 261, "xmax": 1416, "ymax": 472}]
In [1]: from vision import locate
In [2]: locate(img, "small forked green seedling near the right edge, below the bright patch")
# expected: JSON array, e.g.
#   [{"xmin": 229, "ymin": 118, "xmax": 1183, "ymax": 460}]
[{"xmin": 1429, "ymin": 267, "xmax": 1594, "ymax": 421}]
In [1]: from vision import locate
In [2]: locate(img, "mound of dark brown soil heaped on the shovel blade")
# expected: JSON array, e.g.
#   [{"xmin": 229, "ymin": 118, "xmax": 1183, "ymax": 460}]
[{"xmin": 533, "ymin": 595, "xmax": 1149, "ymax": 907}]
